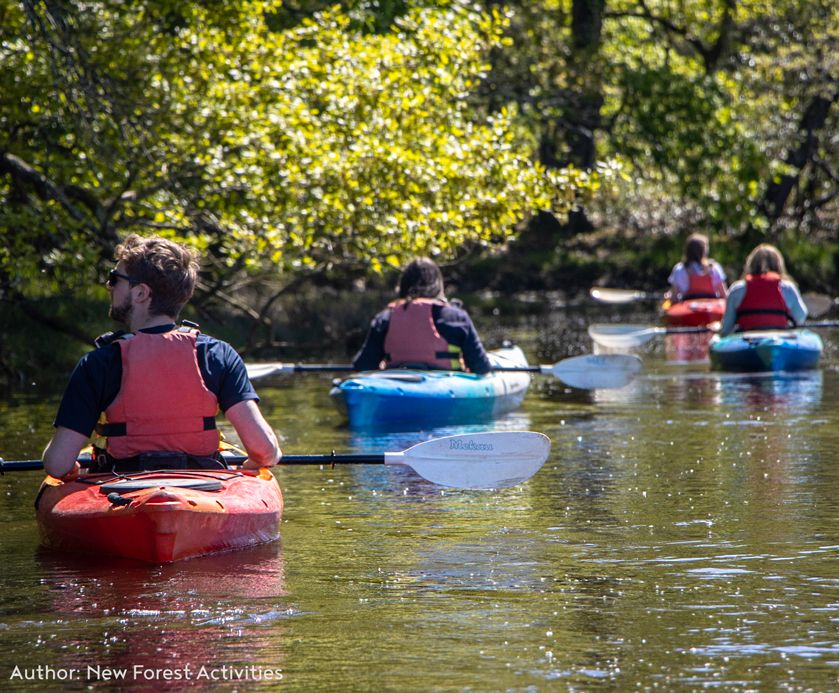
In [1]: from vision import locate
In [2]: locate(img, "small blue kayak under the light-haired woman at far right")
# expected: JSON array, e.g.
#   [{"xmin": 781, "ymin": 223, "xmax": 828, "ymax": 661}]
[{"xmin": 708, "ymin": 330, "xmax": 824, "ymax": 372}]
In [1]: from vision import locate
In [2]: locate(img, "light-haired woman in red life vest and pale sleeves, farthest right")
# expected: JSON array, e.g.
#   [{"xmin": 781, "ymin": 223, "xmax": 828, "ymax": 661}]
[{"xmin": 720, "ymin": 243, "xmax": 807, "ymax": 335}]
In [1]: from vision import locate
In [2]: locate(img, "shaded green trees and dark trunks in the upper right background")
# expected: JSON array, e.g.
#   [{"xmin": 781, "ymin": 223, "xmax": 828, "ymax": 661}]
[{"xmin": 482, "ymin": 0, "xmax": 839, "ymax": 252}]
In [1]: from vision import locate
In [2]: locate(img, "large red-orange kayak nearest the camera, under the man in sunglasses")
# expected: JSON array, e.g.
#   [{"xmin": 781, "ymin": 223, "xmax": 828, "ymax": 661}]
[{"xmin": 36, "ymin": 469, "xmax": 283, "ymax": 563}]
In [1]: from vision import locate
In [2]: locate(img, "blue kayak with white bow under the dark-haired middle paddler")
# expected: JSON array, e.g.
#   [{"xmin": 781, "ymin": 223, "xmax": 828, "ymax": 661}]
[{"xmin": 329, "ymin": 347, "xmax": 530, "ymax": 428}]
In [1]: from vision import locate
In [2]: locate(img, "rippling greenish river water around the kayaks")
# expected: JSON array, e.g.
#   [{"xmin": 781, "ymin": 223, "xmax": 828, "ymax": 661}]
[{"xmin": 0, "ymin": 314, "xmax": 839, "ymax": 693}]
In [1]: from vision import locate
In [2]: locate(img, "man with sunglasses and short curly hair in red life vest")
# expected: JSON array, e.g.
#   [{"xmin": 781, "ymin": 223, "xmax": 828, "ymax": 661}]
[{"xmin": 43, "ymin": 234, "xmax": 282, "ymax": 478}]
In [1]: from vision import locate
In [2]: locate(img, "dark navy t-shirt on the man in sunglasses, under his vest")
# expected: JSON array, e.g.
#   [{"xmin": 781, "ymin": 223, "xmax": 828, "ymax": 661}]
[{"xmin": 53, "ymin": 324, "xmax": 259, "ymax": 436}]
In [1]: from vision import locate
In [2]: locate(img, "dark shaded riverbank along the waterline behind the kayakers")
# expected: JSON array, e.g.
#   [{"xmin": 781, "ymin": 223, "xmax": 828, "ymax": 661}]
[{"xmin": 0, "ymin": 222, "xmax": 839, "ymax": 385}]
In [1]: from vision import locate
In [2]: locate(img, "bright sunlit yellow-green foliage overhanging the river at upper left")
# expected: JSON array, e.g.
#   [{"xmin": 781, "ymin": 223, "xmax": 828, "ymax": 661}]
[{"xmin": 0, "ymin": 0, "xmax": 613, "ymax": 314}]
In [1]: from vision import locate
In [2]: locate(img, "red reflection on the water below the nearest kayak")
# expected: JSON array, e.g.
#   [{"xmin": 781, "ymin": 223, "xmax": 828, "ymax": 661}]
[{"xmin": 3, "ymin": 542, "xmax": 294, "ymax": 691}]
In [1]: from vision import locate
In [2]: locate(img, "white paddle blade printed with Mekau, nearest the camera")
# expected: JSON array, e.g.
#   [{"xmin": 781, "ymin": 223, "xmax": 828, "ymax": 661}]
[{"xmin": 385, "ymin": 431, "xmax": 551, "ymax": 489}]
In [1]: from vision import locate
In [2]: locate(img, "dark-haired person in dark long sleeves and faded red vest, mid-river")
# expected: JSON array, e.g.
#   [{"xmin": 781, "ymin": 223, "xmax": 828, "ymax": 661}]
[{"xmin": 353, "ymin": 257, "xmax": 492, "ymax": 375}]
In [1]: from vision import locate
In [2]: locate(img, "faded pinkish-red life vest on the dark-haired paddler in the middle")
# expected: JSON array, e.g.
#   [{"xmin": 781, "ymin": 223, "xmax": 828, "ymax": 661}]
[{"xmin": 385, "ymin": 298, "xmax": 463, "ymax": 371}]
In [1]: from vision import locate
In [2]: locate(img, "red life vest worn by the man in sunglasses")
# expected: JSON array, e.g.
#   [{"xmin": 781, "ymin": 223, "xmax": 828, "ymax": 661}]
[{"xmin": 97, "ymin": 327, "xmax": 220, "ymax": 459}]
